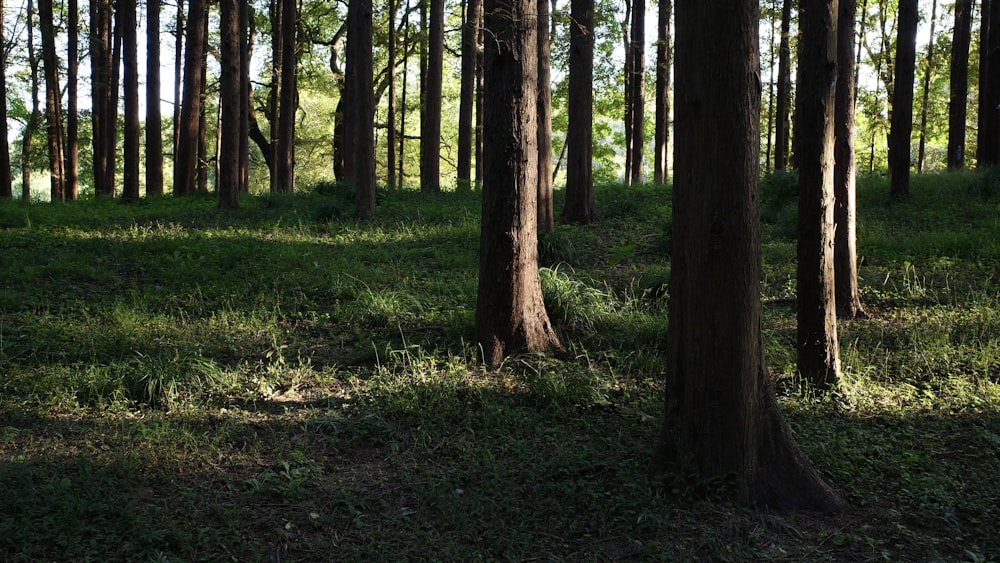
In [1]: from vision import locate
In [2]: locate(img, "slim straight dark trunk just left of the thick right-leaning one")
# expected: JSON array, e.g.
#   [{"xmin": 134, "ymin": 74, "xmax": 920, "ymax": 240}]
[{"xmin": 146, "ymin": 0, "xmax": 163, "ymax": 195}]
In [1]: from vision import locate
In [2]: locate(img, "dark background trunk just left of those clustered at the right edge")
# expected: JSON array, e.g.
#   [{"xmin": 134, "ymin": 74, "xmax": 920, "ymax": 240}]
[{"xmin": 948, "ymin": 0, "xmax": 972, "ymax": 170}]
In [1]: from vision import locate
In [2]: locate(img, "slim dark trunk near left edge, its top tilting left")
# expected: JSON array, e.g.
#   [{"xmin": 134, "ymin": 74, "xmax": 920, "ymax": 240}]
[{"xmin": 38, "ymin": 0, "xmax": 66, "ymax": 201}]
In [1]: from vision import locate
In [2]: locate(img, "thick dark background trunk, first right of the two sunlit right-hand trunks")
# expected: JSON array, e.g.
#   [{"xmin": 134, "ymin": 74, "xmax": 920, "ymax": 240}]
[{"xmin": 889, "ymin": 0, "xmax": 919, "ymax": 198}]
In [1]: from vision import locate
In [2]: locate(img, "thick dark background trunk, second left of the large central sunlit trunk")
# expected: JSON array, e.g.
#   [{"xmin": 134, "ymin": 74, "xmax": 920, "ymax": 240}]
[{"xmin": 420, "ymin": 0, "xmax": 444, "ymax": 192}]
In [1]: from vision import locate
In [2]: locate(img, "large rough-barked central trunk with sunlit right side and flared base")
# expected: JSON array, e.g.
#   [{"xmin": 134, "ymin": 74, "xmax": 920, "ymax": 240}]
[{"xmin": 476, "ymin": 0, "xmax": 561, "ymax": 367}]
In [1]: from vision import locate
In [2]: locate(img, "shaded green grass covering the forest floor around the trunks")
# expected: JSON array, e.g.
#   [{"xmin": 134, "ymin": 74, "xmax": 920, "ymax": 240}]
[{"xmin": 0, "ymin": 174, "xmax": 1000, "ymax": 561}]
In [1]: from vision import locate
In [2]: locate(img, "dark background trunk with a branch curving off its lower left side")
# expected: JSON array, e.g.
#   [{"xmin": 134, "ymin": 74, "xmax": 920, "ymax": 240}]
[{"xmin": 275, "ymin": 0, "xmax": 298, "ymax": 193}]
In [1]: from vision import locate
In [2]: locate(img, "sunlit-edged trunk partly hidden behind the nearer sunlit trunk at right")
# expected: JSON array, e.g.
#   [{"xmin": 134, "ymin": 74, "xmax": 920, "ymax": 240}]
[{"xmin": 833, "ymin": 0, "xmax": 865, "ymax": 319}]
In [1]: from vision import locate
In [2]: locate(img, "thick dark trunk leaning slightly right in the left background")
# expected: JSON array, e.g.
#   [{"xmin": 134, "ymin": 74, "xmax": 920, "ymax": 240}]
[{"xmin": 174, "ymin": 0, "xmax": 207, "ymax": 195}]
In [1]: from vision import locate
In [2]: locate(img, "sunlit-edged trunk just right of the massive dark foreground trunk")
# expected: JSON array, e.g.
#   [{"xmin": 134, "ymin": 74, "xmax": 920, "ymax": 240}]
[{"xmin": 795, "ymin": 0, "xmax": 840, "ymax": 390}]
